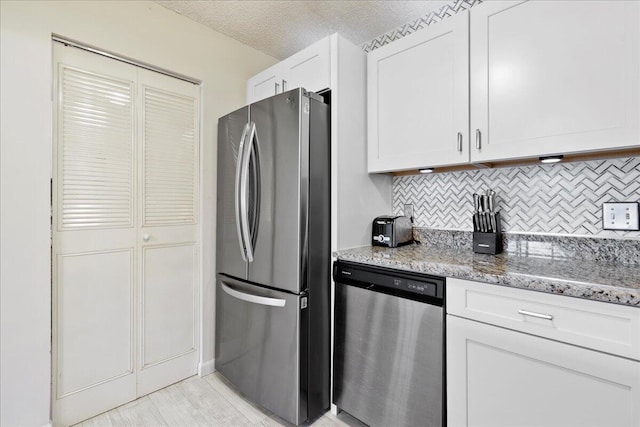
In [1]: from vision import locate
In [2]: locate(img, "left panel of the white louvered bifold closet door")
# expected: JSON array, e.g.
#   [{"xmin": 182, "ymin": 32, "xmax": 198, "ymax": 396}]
[{"xmin": 52, "ymin": 43, "xmax": 137, "ymax": 425}]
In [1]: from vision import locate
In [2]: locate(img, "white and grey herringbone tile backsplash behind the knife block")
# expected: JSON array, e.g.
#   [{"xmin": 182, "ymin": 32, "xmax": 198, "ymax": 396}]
[{"xmin": 393, "ymin": 157, "xmax": 640, "ymax": 238}]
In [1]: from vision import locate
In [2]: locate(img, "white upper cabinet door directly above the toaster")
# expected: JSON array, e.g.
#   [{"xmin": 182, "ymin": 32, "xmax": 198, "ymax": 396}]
[{"xmin": 367, "ymin": 12, "xmax": 469, "ymax": 172}]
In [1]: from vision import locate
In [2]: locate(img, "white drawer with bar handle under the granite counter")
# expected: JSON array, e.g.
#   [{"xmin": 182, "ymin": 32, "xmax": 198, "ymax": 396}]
[{"xmin": 447, "ymin": 279, "xmax": 640, "ymax": 360}]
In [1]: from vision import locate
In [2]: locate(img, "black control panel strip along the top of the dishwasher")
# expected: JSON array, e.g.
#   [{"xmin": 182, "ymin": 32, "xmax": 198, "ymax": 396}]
[{"xmin": 333, "ymin": 261, "xmax": 445, "ymax": 299}]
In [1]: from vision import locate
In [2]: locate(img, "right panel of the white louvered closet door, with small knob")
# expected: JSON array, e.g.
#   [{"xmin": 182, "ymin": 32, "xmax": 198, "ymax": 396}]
[{"xmin": 138, "ymin": 70, "xmax": 199, "ymax": 394}]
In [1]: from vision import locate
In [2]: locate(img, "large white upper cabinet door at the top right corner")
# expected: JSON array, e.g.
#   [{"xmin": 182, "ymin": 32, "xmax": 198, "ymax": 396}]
[{"xmin": 471, "ymin": 1, "xmax": 640, "ymax": 161}]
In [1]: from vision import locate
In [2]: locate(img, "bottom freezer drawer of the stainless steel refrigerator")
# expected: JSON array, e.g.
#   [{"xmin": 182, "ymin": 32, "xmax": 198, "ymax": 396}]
[{"xmin": 215, "ymin": 275, "xmax": 307, "ymax": 424}]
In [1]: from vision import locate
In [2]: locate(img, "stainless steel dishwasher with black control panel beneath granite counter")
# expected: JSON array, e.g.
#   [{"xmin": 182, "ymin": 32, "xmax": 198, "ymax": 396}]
[{"xmin": 333, "ymin": 261, "xmax": 446, "ymax": 427}]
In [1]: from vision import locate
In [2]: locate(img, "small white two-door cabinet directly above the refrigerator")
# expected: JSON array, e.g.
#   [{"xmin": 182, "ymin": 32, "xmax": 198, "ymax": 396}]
[{"xmin": 247, "ymin": 37, "xmax": 331, "ymax": 104}]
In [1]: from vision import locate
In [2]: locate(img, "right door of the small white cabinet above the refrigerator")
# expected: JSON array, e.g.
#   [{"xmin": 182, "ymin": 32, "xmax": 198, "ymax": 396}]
[{"xmin": 281, "ymin": 37, "xmax": 331, "ymax": 92}]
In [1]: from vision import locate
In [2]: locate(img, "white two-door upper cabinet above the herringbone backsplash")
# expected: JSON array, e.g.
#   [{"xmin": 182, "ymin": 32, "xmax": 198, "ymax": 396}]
[{"xmin": 367, "ymin": 0, "xmax": 640, "ymax": 172}]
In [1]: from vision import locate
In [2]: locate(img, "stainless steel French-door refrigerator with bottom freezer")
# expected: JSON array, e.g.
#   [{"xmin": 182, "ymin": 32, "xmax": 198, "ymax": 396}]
[{"xmin": 215, "ymin": 89, "xmax": 330, "ymax": 424}]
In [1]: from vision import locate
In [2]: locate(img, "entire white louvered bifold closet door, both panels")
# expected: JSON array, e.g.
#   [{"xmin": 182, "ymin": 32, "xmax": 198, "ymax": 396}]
[{"xmin": 52, "ymin": 43, "xmax": 199, "ymax": 425}]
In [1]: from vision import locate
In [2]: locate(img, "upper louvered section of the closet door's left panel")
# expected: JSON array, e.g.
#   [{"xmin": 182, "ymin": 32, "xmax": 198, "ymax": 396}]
[{"xmin": 58, "ymin": 66, "xmax": 134, "ymax": 230}]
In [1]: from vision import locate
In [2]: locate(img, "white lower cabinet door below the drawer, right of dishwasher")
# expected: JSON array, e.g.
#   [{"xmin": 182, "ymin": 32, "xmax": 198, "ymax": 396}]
[{"xmin": 447, "ymin": 315, "xmax": 640, "ymax": 427}]
